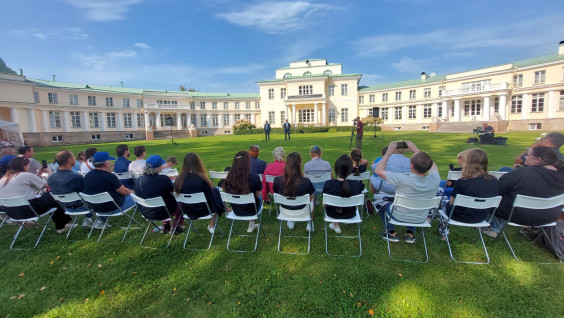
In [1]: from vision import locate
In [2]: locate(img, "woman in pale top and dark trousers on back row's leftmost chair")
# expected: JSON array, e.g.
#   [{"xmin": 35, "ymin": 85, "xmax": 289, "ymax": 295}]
[{"xmin": 0, "ymin": 157, "xmax": 71, "ymax": 233}]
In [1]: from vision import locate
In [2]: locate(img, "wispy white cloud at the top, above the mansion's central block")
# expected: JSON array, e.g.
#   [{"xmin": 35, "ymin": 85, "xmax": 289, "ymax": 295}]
[{"xmin": 217, "ymin": 1, "xmax": 332, "ymax": 33}]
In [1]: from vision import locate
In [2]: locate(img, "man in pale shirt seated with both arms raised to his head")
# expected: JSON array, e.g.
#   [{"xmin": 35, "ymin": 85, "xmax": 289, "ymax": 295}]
[{"xmin": 374, "ymin": 141, "xmax": 441, "ymax": 244}]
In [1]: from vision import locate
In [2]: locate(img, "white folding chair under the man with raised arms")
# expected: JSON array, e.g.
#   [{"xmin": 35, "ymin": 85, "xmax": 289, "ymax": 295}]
[{"xmin": 384, "ymin": 195, "xmax": 442, "ymax": 263}]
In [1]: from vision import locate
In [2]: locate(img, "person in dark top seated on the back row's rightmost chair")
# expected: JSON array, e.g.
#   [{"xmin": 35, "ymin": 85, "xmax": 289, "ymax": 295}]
[{"xmin": 483, "ymin": 146, "xmax": 564, "ymax": 237}]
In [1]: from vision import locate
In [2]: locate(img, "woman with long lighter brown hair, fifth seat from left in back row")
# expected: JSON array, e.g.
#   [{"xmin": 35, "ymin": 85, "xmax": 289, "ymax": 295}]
[{"xmin": 174, "ymin": 152, "xmax": 224, "ymax": 233}]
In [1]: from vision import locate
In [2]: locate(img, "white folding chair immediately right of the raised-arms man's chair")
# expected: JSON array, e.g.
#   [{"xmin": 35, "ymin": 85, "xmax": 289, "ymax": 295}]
[{"xmin": 439, "ymin": 194, "xmax": 501, "ymax": 264}]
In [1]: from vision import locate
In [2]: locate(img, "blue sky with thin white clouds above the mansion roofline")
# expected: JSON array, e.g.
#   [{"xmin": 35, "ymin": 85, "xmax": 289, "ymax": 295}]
[{"xmin": 0, "ymin": 0, "xmax": 564, "ymax": 93}]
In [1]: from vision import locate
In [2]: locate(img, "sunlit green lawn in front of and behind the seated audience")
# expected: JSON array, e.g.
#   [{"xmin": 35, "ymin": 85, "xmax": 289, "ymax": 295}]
[{"xmin": 0, "ymin": 132, "xmax": 564, "ymax": 317}]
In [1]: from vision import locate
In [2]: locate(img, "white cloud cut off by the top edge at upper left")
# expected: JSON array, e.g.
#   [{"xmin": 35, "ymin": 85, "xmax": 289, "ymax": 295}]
[{"xmin": 64, "ymin": 0, "xmax": 143, "ymax": 21}]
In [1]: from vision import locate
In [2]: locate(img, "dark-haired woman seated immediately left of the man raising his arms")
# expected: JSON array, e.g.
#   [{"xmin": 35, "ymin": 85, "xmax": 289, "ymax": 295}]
[{"xmin": 323, "ymin": 154, "xmax": 364, "ymax": 233}]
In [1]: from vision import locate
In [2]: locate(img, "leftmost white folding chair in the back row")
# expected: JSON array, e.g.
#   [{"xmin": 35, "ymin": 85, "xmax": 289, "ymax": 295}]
[{"xmin": 0, "ymin": 197, "xmax": 57, "ymax": 250}]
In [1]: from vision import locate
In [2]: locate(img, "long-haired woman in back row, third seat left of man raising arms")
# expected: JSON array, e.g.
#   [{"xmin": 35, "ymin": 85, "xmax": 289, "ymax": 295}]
[{"xmin": 222, "ymin": 151, "xmax": 262, "ymax": 233}]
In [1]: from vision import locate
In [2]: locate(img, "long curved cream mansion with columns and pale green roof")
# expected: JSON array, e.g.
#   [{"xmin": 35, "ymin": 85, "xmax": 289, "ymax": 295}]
[{"xmin": 0, "ymin": 42, "xmax": 564, "ymax": 146}]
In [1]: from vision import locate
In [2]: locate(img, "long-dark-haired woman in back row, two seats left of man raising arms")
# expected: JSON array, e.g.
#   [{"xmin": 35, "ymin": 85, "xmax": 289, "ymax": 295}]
[{"xmin": 273, "ymin": 152, "xmax": 315, "ymax": 232}]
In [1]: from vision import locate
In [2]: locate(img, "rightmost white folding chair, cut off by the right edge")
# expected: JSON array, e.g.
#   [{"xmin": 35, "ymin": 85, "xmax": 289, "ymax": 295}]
[{"xmin": 501, "ymin": 194, "xmax": 564, "ymax": 264}]
